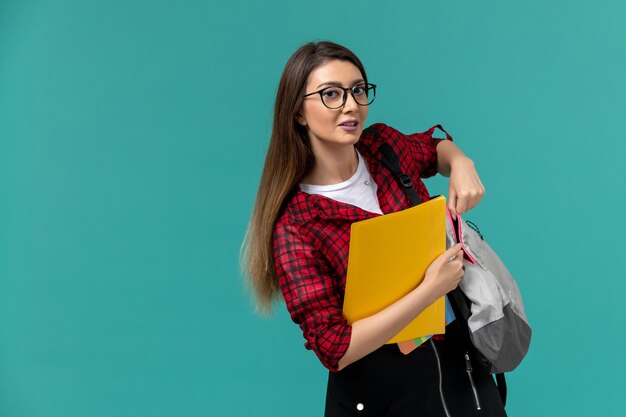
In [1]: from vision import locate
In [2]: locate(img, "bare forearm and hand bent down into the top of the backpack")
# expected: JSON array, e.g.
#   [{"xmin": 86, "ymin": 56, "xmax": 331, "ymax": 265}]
[{"xmin": 437, "ymin": 140, "xmax": 485, "ymax": 218}]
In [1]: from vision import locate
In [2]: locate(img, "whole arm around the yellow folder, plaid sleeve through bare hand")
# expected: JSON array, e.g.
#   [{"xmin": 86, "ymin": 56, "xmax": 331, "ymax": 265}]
[{"xmin": 274, "ymin": 221, "xmax": 463, "ymax": 371}]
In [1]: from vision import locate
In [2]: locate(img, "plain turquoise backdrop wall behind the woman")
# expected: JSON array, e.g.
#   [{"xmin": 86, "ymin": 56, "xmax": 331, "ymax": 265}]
[{"xmin": 0, "ymin": 0, "xmax": 626, "ymax": 417}]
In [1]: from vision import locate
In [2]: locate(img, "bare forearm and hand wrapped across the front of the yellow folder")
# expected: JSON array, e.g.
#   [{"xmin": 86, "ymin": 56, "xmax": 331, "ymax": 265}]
[{"xmin": 339, "ymin": 244, "xmax": 463, "ymax": 370}]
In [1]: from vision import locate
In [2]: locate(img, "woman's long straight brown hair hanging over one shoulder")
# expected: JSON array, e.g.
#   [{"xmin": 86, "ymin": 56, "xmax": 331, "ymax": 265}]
[{"xmin": 243, "ymin": 42, "xmax": 367, "ymax": 314}]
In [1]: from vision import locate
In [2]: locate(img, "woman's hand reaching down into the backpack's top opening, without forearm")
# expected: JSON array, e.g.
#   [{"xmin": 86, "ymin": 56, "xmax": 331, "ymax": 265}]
[{"xmin": 448, "ymin": 155, "xmax": 485, "ymax": 219}]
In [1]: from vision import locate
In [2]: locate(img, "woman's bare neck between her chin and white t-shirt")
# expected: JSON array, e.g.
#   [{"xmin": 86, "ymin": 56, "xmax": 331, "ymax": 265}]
[{"xmin": 302, "ymin": 145, "xmax": 359, "ymax": 185}]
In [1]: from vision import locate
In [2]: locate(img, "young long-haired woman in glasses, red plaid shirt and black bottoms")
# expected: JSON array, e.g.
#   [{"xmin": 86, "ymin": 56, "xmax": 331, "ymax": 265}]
[{"xmin": 245, "ymin": 42, "xmax": 506, "ymax": 417}]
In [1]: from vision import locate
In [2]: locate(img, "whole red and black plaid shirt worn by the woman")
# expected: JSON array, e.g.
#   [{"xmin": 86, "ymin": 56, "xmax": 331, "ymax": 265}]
[{"xmin": 273, "ymin": 124, "xmax": 451, "ymax": 371}]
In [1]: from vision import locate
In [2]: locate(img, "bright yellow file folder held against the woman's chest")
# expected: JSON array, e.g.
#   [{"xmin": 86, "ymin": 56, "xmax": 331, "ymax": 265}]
[{"xmin": 343, "ymin": 196, "xmax": 446, "ymax": 343}]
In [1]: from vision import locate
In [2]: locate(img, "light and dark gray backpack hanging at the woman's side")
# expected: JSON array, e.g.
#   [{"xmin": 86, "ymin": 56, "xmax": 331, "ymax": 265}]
[{"xmin": 446, "ymin": 213, "xmax": 532, "ymax": 373}]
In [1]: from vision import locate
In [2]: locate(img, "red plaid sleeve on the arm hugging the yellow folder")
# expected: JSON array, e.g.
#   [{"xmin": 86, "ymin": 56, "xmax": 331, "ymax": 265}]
[{"xmin": 273, "ymin": 221, "xmax": 352, "ymax": 371}]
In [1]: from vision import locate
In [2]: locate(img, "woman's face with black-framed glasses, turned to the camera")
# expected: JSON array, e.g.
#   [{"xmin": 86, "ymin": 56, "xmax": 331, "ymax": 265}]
[{"xmin": 297, "ymin": 60, "xmax": 367, "ymax": 149}]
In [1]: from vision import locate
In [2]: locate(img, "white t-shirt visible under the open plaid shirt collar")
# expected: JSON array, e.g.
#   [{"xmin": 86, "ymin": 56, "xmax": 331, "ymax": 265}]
[{"xmin": 300, "ymin": 151, "xmax": 383, "ymax": 214}]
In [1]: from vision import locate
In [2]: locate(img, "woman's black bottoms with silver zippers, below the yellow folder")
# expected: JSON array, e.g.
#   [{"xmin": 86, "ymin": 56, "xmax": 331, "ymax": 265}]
[{"xmin": 324, "ymin": 323, "xmax": 506, "ymax": 417}]
